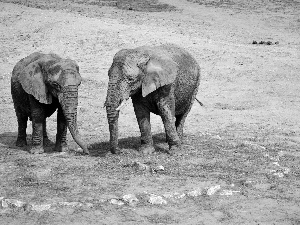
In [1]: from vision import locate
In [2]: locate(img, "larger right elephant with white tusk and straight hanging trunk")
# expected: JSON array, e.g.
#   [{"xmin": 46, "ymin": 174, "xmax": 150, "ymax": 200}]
[{"xmin": 105, "ymin": 44, "xmax": 200, "ymax": 154}]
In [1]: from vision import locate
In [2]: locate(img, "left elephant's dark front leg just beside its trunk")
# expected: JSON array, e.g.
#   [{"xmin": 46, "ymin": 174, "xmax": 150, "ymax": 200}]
[{"xmin": 54, "ymin": 107, "xmax": 68, "ymax": 152}]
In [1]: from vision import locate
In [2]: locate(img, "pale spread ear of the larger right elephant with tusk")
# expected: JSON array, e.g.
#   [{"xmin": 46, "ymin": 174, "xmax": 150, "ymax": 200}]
[{"xmin": 142, "ymin": 58, "xmax": 177, "ymax": 97}]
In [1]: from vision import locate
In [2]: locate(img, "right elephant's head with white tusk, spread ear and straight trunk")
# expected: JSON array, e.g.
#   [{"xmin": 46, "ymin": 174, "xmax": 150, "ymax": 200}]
[{"xmin": 105, "ymin": 46, "xmax": 177, "ymax": 153}]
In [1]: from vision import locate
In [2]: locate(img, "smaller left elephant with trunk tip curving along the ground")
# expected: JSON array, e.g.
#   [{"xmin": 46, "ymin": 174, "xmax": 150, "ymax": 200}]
[{"xmin": 11, "ymin": 52, "xmax": 89, "ymax": 154}]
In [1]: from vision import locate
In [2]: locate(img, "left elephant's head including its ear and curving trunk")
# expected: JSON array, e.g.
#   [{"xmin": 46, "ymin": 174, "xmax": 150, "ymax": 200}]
[{"xmin": 15, "ymin": 53, "xmax": 88, "ymax": 153}]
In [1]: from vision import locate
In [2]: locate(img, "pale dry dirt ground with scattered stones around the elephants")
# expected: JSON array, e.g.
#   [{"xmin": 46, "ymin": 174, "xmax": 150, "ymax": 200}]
[{"xmin": 0, "ymin": 0, "xmax": 300, "ymax": 225}]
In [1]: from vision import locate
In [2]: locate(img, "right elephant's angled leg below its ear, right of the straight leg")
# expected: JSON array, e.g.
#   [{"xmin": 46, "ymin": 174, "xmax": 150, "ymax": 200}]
[{"xmin": 158, "ymin": 90, "xmax": 181, "ymax": 154}]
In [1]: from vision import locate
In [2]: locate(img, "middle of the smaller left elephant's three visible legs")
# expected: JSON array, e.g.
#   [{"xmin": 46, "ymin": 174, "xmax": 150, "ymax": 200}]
[{"xmin": 29, "ymin": 96, "xmax": 45, "ymax": 154}]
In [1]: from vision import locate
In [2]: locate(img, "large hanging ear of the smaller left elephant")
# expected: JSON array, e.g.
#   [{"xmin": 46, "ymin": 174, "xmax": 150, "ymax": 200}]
[{"xmin": 19, "ymin": 59, "xmax": 52, "ymax": 104}]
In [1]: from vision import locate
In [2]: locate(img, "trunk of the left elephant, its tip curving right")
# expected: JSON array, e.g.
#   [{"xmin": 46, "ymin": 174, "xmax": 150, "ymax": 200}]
[{"xmin": 58, "ymin": 86, "xmax": 89, "ymax": 154}]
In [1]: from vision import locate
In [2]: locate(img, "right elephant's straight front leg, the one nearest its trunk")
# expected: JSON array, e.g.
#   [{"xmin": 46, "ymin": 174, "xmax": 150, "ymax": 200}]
[{"xmin": 132, "ymin": 98, "xmax": 155, "ymax": 154}]
